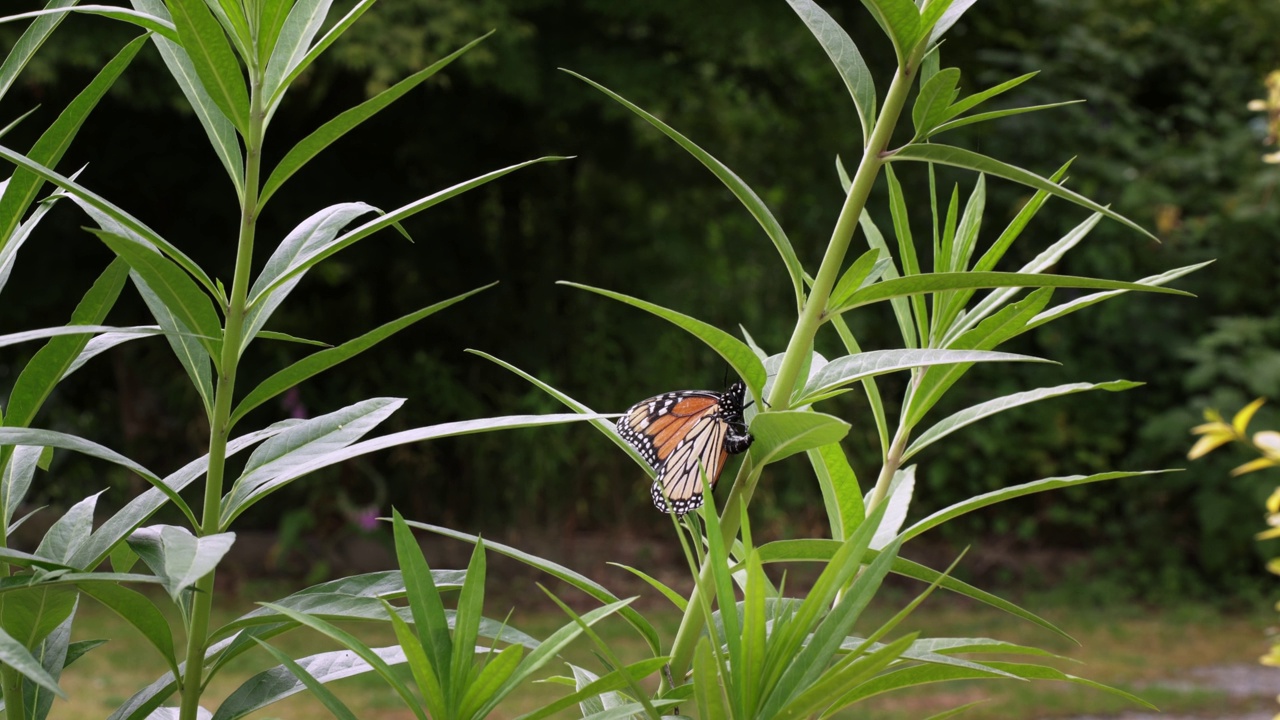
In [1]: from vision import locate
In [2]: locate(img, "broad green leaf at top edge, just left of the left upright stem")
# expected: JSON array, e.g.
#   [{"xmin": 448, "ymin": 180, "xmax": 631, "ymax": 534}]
[{"xmin": 166, "ymin": 0, "xmax": 250, "ymax": 135}]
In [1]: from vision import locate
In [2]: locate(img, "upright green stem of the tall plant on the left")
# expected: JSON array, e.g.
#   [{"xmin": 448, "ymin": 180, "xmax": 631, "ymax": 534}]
[{"xmin": 179, "ymin": 92, "xmax": 265, "ymax": 720}]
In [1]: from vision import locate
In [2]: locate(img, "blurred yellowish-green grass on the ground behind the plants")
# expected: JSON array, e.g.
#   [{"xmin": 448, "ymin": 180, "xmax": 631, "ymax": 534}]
[{"xmin": 64, "ymin": 580, "xmax": 1280, "ymax": 720}]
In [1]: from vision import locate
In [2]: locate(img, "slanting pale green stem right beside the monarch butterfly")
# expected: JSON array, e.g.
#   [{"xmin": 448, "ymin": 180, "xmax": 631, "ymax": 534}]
[{"xmin": 671, "ymin": 58, "xmax": 919, "ymax": 678}]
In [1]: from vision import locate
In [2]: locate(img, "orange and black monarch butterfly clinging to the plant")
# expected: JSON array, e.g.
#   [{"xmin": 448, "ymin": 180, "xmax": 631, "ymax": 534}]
[{"xmin": 618, "ymin": 382, "xmax": 754, "ymax": 515}]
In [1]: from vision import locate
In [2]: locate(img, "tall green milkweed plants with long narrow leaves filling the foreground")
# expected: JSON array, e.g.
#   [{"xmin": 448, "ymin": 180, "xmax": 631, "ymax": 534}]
[{"xmin": 0, "ymin": 0, "xmax": 1197, "ymax": 720}]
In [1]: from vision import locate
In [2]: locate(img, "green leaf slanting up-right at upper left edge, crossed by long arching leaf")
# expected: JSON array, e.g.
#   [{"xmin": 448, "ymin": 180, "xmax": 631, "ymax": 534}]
[{"xmin": 0, "ymin": 36, "xmax": 146, "ymax": 249}]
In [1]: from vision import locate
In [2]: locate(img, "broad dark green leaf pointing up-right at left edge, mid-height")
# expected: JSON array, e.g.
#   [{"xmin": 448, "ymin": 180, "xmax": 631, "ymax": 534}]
[{"xmin": 5, "ymin": 259, "xmax": 129, "ymax": 427}]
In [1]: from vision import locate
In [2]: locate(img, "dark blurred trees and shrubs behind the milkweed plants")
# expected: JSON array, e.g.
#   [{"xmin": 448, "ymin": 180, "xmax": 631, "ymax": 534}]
[{"xmin": 0, "ymin": 0, "xmax": 1280, "ymax": 600}]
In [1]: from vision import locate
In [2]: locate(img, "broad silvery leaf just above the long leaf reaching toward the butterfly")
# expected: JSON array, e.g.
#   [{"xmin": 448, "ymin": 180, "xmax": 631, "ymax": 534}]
[{"xmin": 219, "ymin": 397, "xmax": 404, "ymax": 529}]
